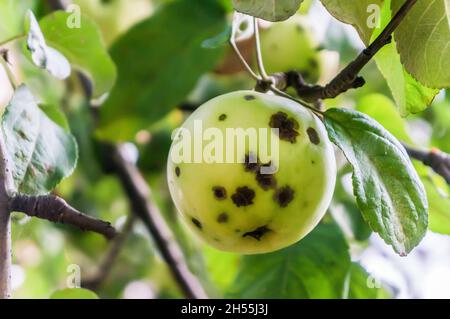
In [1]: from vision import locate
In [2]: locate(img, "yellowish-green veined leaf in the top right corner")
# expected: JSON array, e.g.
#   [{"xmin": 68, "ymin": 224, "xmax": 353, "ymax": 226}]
[{"xmin": 391, "ymin": 0, "xmax": 450, "ymax": 89}]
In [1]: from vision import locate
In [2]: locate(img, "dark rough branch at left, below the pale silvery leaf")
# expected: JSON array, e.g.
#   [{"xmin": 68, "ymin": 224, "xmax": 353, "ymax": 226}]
[{"xmin": 9, "ymin": 194, "xmax": 117, "ymax": 239}]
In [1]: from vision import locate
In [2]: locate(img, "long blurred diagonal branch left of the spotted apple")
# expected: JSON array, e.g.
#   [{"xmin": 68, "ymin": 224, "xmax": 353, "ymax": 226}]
[{"xmin": 109, "ymin": 146, "xmax": 207, "ymax": 299}]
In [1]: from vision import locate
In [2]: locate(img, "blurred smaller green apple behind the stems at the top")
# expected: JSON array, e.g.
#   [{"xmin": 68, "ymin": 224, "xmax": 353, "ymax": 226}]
[{"xmin": 261, "ymin": 15, "xmax": 322, "ymax": 83}]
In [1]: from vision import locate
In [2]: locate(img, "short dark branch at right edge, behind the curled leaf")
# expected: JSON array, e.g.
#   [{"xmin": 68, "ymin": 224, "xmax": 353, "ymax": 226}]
[{"xmin": 403, "ymin": 144, "xmax": 450, "ymax": 185}]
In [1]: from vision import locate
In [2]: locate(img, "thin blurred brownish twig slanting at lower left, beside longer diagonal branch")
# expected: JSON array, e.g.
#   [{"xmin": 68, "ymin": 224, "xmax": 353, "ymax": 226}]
[{"xmin": 82, "ymin": 215, "xmax": 136, "ymax": 290}]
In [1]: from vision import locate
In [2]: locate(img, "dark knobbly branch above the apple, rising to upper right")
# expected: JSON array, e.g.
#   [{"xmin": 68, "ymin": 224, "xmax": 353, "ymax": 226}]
[{"xmin": 275, "ymin": 0, "xmax": 417, "ymax": 103}]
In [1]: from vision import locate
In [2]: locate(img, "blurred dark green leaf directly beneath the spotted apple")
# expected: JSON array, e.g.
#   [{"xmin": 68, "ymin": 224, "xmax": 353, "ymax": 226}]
[{"xmin": 229, "ymin": 223, "xmax": 350, "ymax": 299}]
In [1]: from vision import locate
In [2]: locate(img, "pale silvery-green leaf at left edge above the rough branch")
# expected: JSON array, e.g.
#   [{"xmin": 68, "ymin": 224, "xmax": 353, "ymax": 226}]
[{"xmin": 2, "ymin": 85, "xmax": 77, "ymax": 195}]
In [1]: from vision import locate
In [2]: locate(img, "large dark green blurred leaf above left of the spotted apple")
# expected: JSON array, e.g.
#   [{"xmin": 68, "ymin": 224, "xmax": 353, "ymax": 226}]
[{"xmin": 98, "ymin": 0, "xmax": 226, "ymax": 140}]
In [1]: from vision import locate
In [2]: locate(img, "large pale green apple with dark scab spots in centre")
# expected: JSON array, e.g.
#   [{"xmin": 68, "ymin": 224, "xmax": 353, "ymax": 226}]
[{"xmin": 167, "ymin": 91, "xmax": 336, "ymax": 254}]
